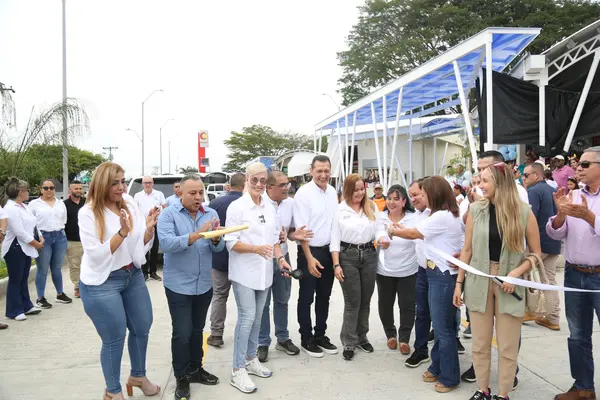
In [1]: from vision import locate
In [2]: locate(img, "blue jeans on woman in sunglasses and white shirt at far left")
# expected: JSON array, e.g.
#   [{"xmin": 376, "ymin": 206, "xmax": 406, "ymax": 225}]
[{"xmin": 35, "ymin": 229, "xmax": 67, "ymax": 299}]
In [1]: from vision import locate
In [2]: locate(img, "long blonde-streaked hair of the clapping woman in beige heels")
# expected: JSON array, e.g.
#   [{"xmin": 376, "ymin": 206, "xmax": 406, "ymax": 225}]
[{"xmin": 86, "ymin": 161, "xmax": 133, "ymax": 243}]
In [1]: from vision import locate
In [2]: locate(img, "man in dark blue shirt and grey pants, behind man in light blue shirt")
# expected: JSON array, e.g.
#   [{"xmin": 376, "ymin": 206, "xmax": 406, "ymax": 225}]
[{"xmin": 206, "ymin": 172, "xmax": 246, "ymax": 347}]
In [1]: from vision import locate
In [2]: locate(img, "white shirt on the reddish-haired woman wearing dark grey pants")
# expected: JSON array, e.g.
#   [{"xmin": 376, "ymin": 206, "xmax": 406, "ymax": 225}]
[{"xmin": 329, "ymin": 201, "xmax": 377, "ymax": 252}]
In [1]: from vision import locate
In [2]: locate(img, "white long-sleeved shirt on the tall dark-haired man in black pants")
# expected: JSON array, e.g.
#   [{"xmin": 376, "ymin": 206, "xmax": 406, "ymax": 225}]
[{"xmin": 294, "ymin": 180, "xmax": 338, "ymax": 247}]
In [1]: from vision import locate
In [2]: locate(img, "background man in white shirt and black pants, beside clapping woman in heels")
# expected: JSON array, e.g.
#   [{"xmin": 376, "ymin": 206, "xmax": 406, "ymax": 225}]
[{"xmin": 133, "ymin": 176, "xmax": 167, "ymax": 281}]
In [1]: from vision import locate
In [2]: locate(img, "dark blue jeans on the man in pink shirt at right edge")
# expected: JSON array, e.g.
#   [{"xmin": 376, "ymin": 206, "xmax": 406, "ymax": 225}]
[{"xmin": 565, "ymin": 266, "xmax": 600, "ymax": 391}]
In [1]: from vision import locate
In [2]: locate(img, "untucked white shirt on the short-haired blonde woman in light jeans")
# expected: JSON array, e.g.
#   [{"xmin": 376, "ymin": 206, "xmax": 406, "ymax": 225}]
[{"xmin": 225, "ymin": 193, "xmax": 280, "ymax": 290}]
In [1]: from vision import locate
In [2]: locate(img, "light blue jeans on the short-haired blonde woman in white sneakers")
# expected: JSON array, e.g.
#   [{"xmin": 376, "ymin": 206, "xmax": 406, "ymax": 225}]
[{"xmin": 231, "ymin": 281, "xmax": 268, "ymax": 369}]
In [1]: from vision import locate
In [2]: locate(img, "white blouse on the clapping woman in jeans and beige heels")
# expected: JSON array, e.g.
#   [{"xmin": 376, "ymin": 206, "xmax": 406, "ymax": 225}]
[{"xmin": 79, "ymin": 196, "xmax": 153, "ymax": 286}]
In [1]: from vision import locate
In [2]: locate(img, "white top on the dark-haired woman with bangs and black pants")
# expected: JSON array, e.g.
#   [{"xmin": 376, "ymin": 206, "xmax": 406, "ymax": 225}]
[{"xmin": 377, "ymin": 212, "xmax": 419, "ymax": 278}]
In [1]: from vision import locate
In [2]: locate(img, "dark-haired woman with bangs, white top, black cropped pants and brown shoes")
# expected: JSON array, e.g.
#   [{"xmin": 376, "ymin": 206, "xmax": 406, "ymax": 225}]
[{"xmin": 377, "ymin": 185, "xmax": 419, "ymax": 355}]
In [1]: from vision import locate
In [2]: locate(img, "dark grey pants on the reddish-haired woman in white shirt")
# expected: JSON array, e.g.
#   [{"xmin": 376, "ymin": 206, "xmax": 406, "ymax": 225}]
[{"xmin": 340, "ymin": 249, "xmax": 377, "ymax": 349}]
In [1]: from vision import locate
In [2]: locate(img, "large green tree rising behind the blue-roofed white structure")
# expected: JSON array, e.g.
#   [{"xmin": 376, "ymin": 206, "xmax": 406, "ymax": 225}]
[{"xmin": 338, "ymin": 0, "xmax": 600, "ymax": 105}]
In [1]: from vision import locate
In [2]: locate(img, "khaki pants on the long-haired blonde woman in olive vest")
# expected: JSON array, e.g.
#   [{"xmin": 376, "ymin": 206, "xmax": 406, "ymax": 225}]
[{"xmin": 469, "ymin": 263, "xmax": 524, "ymax": 394}]
